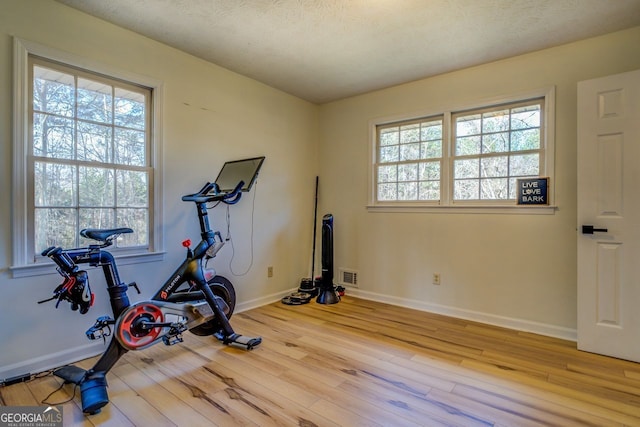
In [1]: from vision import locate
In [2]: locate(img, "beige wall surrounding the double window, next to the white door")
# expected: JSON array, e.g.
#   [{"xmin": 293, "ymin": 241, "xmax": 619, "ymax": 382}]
[{"xmin": 320, "ymin": 28, "xmax": 640, "ymax": 337}]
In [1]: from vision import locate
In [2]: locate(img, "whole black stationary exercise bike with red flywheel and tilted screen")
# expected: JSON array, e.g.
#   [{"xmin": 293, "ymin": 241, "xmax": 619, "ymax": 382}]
[{"xmin": 40, "ymin": 157, "xmax": 264, "ymax": 414}]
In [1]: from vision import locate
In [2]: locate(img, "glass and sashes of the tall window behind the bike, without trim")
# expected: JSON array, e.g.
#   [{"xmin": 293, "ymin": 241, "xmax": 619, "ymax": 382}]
[{"xmin": 27, "ymin": 57, "xmax": 153, "ymax": 253}]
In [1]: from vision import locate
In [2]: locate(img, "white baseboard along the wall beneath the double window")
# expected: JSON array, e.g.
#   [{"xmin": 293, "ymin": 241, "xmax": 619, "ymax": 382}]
[{"xmin": 347, "ymin": 288, "xmax": 578, "ymax": 342}]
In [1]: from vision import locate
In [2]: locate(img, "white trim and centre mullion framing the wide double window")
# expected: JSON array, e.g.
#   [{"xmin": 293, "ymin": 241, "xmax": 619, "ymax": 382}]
[{"xmin": 366, "ymin": 86, "xmax": 557, "ymax": 215}]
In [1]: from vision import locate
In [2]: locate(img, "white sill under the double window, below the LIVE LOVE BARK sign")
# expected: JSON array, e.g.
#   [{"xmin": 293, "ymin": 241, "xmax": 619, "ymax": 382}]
[{"xmin": 367, "ymin": 205, "xmax": 558, "ymax": 215}]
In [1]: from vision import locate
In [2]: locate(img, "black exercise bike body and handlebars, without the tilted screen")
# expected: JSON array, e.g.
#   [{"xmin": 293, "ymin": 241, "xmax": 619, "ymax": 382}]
[{"xmin": 41, "ymin": 175, "xmax": 262, "ymax": 414}]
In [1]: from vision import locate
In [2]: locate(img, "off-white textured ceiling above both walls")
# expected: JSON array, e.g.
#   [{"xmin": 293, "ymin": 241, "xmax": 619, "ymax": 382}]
[{"xmin": 57, "ymin": 0, "xmax": 640, "ymax": 103}]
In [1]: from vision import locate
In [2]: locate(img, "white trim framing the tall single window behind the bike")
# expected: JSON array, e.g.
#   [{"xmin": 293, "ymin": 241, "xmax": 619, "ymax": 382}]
[{"xmin": 10, "ymin": 37, "xmax": 165, "ymax": 277}]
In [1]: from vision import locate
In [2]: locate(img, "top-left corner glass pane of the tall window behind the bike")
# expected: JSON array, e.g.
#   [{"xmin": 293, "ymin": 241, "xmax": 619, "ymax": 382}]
[{"xmin": 32, "ymin": 66, "xmax": 75, "ymax": 117}]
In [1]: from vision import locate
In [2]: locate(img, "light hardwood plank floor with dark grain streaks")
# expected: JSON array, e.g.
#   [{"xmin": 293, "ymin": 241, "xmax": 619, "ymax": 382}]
[{"xmin": 0, "ymin": 296, "xmax": 640, "ymax": 427}]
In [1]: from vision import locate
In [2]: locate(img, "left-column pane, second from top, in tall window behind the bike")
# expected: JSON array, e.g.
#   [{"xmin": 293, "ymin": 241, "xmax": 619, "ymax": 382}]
[{"xmin": 33, "ymin": 113, "xmax": 75, "ymax": 159}]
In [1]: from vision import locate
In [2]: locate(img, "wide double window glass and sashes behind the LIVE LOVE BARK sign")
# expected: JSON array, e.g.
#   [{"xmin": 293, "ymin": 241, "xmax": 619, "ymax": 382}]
[{"xmin": 370, "ymin": 89, "xmax": 553, "ymax": 209}]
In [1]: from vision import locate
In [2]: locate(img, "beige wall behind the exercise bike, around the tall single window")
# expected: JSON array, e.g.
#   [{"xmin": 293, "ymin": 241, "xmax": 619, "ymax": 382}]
[{"xmin": 0, "ymin": 0, "xmax": 318, "ymax": 379}]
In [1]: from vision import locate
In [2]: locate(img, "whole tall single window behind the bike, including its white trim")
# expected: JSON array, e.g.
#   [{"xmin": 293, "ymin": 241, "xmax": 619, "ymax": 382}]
[{"xmin": 12, "ymin": 39, "xmax": 162, "ymax": 277}]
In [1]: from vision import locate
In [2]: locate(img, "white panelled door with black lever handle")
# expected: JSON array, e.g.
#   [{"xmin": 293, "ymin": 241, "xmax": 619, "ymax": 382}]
[{"xmin": 578, "ymin": 70, "xmax": 640, "ymax": 362}]
